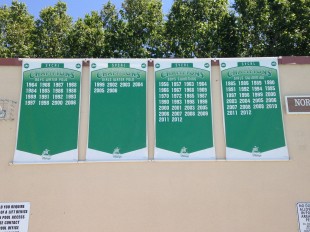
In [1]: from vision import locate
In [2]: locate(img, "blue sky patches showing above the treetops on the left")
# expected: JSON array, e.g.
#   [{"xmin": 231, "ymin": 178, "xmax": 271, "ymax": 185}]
[{"xmin": 0, "ymin": 0, "xmax": 173, "ymax": 21}]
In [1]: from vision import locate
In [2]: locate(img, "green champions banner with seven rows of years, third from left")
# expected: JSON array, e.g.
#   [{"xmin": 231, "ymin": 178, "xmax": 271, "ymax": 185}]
[{"xmin": 154, "ymin": 59, "xmax": 215, "ymax": 160}]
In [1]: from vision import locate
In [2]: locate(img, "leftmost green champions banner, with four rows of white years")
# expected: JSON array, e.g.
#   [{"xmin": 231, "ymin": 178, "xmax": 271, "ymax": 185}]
[{"xmin": 14, "ymin": 59, "xmax": 82, "ymax": 163}]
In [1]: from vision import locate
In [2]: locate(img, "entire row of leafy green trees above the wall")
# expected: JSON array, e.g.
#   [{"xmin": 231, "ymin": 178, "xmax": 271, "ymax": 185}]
[{"xmin": 0, "ymin": 0, "xmax": 310, "ymax": 58}]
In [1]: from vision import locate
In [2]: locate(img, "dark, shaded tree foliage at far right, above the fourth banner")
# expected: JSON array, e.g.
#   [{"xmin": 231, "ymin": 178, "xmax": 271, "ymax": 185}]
[{"xmin": 234, "ymin": 0, "xmax": 310, "ymax": 56}]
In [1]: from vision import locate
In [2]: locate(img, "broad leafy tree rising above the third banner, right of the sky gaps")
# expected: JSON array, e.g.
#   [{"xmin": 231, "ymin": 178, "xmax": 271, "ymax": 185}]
[{"xmin": 166, "ymin": 0, "xmax": 230, "ymax": 57}]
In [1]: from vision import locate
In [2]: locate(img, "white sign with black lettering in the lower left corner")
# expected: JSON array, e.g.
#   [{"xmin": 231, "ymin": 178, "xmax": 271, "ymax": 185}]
[{"xmin": 0, "ymin": 202, "xmax": 30, "ymax": 232}]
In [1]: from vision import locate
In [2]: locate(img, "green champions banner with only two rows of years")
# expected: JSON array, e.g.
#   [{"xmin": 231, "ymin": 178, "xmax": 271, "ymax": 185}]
[{"xmin": 86, "ymin": 59, "xmax": 148, "ymax": 161}]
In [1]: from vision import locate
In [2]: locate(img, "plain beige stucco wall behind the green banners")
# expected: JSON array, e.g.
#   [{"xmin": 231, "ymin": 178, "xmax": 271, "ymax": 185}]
[{"xmin": 0, "ymin": 62, "xmax": 310, "ymax": 232}]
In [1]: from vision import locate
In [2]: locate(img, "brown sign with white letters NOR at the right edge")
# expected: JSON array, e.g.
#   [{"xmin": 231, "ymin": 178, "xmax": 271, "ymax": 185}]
[{"xmin": 285, "ymin": 96, "xmax": 310, "ymax": 114}]
